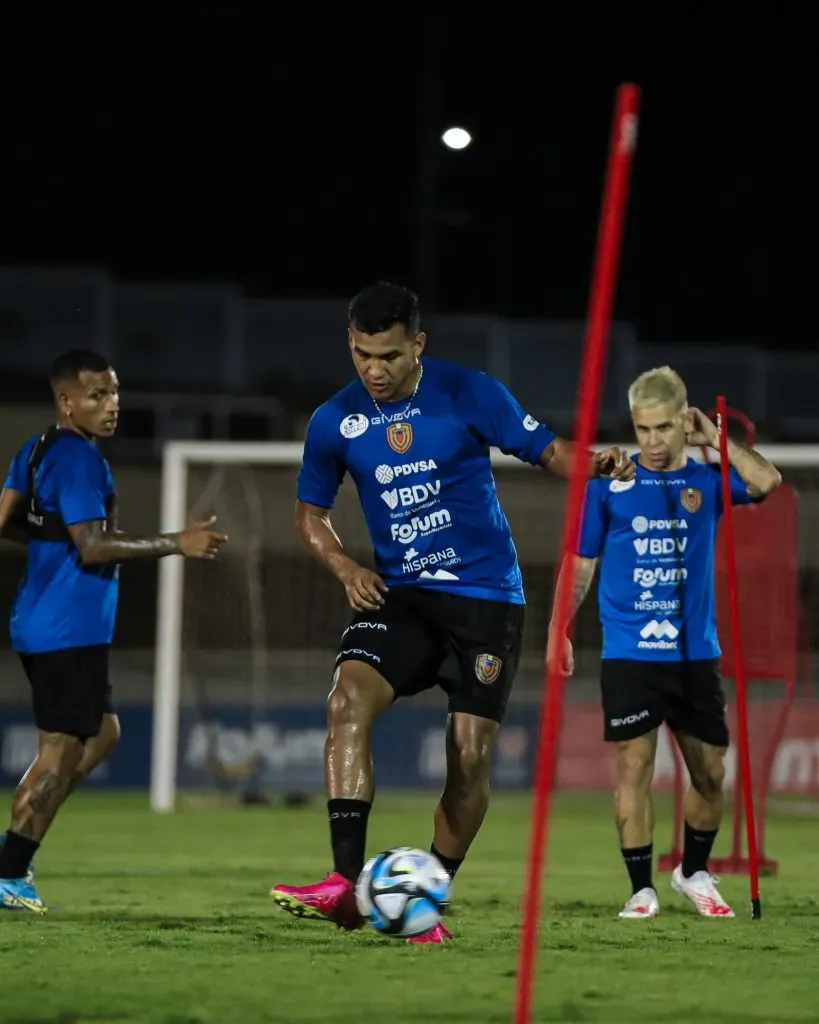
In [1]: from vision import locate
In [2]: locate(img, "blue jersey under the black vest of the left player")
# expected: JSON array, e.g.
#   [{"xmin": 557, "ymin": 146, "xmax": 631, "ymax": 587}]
[{"xmin": 5, "ymin": 434, "xmax": 119, "ymax": 654}]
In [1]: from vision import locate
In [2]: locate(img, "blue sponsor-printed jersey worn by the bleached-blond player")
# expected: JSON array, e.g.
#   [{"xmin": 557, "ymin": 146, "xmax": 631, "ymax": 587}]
[{"xmin": 577, "ymin": 457, "xmax": 750, "ymax": 662}]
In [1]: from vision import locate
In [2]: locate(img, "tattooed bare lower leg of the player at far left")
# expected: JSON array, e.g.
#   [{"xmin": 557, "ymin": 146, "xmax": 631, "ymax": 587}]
[{"xmin": 11, "ymin": 732, "xmax": 83, "ymax": 843}]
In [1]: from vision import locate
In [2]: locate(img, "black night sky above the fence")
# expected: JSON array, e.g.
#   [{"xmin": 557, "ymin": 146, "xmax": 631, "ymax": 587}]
[{"xmin": 0, "ymin": 3, "xmax": 818, "ymax": 348}]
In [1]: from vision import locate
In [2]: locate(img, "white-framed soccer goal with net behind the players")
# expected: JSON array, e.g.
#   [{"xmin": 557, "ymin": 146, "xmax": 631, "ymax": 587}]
[{"xmin": 150, "ymin": 441, "xmax": 819, "ymax": 812}]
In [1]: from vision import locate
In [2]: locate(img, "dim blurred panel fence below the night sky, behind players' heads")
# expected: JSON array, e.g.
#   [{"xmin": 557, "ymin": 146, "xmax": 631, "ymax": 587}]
[{"xmin": 0, "ymin": 267, "xmax": 819, "ymax": 441}]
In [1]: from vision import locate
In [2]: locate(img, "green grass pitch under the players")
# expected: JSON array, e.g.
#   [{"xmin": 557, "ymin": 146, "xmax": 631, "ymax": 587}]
[{"xmin": 0, "ymin": 793, "xmax": 819, "ymax": 1024}]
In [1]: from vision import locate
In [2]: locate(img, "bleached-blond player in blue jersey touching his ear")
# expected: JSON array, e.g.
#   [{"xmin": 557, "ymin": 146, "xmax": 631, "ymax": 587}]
[{"xmin": 548, "ymin": 367, "xmax": 780, "ymax": 919}]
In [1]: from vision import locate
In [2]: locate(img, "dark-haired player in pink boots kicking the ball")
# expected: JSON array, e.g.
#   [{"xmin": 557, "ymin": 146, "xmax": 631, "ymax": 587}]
[{"xmin": 271, "ymin": 283, "xmax": 634, "ymax": 943}]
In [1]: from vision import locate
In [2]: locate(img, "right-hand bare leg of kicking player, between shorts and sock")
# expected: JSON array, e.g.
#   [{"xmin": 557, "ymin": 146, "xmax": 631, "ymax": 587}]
[{"xmin": 432, "ymin": 712, "xmax": 500, "ymax": 873}]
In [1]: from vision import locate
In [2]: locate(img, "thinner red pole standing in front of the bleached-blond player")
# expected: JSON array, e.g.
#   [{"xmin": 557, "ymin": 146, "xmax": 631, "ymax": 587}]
[{"xmin": 717, "ymin": 395, "xmax": 762, "ymax": 921}]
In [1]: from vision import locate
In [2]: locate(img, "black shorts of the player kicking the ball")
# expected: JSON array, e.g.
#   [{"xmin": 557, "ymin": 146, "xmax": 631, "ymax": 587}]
[{"xmin": 336, "ymin": 587, "xmax": 524, "ymax": 722}]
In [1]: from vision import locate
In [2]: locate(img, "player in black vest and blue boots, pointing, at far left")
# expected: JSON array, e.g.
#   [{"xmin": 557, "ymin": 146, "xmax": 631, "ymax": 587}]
[{"xmin": 0, "ymin": 350, "xmax": 226, "ymax": 913}]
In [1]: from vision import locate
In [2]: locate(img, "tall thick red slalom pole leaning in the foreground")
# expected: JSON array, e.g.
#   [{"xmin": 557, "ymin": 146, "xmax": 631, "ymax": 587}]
[{"xmin": 514, "ymin": 84, "xmax": 640, "ymax": 1024}]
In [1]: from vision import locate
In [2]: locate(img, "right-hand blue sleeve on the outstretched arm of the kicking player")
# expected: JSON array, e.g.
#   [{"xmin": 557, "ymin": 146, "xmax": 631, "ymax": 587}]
[{"xmin": 469, "ymin": 374, "xmax": 557, "ymax": 466}]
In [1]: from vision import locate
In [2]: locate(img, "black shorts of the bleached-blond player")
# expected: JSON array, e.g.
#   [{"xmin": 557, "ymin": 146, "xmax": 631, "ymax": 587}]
[{"xmin": 600, "ymin": 658, "xmax": 729, "ymax": 746}]
